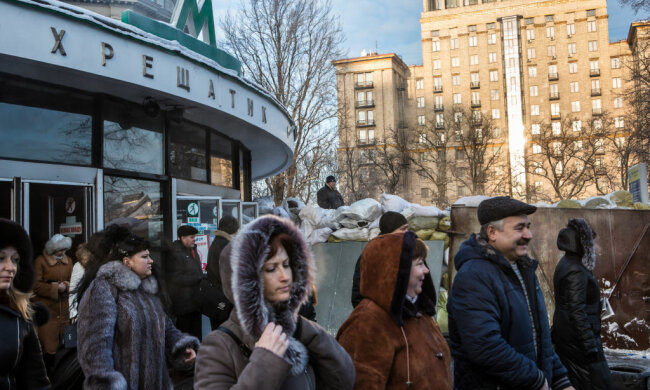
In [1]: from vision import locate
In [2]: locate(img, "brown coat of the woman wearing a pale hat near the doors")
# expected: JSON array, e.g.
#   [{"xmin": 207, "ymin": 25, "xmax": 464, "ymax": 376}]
[{"xmin": 32, "ymin": 252, "xmax": 72, "ymax": 354}]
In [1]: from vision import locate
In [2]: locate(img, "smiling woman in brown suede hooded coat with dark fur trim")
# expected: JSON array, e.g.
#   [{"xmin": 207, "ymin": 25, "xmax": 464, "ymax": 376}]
[{"xmin": 336, "ymin": 231, "xmax": 452, "ymax": 390}]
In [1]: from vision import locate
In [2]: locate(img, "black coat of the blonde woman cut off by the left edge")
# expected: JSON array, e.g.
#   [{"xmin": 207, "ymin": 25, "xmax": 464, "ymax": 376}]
[{"xmin": 0, "ymin": 304, "xmax": 50, "ymax": 390}]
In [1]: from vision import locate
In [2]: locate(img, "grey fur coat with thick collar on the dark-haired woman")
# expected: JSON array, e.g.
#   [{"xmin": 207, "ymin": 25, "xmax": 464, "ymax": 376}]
[{"xmin": 77, "ymin": 261, "xmax": 199, "ymax": 390}]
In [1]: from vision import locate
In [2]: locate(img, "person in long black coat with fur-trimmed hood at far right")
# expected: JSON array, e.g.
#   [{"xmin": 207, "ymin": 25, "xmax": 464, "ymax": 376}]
[{"xmin": 551, "ymin": 218, "xmax": 612, "ymax": 390}]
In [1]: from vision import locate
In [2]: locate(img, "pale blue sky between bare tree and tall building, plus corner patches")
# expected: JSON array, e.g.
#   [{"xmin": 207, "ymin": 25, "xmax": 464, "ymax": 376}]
[{"xmin": 212, "ymin": 0, "xmax": 648, "ymax": 65}]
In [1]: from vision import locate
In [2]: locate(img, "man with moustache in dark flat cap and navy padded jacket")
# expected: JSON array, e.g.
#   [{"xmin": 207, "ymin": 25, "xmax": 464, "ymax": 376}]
[{"xmin": 447, "ymin": 196, "xmax": 573, "ymax": 390}]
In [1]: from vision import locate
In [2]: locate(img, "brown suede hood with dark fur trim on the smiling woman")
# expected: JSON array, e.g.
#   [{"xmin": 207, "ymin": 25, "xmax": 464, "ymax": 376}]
[{"xmin": 361, "ymin": 231, "xmax": 436, "ymax": 326}]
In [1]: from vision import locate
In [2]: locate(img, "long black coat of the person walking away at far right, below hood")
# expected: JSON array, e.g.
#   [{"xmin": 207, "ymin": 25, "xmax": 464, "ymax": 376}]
[{"xmin": 552, "ymin": 253, "xmax": 611, "ymax": 390}]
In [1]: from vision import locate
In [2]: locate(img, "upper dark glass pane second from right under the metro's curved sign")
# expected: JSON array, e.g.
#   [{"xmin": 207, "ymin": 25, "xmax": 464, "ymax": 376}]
[{"xmin": 169, "ymin": 121, "xmax": 207, "ymax": 181}]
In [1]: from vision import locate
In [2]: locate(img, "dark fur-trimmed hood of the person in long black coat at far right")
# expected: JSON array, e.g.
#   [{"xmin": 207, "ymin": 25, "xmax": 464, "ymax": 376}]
[{"xmin": 557, "ymin": 218, "xmax": 596, "ymax": 271}]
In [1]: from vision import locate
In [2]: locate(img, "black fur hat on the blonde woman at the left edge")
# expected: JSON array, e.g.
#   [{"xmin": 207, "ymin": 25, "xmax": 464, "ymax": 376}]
[{"xmin": 0, "ymin": 218, "xmax": 35, "ymax": 293}]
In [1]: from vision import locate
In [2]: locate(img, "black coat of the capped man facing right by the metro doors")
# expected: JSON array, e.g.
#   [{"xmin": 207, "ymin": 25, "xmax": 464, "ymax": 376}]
[{"xmin": 166, "ymin": 240, "xmax": 205, "ymax": 316}]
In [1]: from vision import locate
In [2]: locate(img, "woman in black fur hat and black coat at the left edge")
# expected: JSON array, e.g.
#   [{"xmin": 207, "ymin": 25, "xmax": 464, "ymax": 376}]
[{"xmin": 0, "ymin": 219, "xmax": 50, "ymax": 390}]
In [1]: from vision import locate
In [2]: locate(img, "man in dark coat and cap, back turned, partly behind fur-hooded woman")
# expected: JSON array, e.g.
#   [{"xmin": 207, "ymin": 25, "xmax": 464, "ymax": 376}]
[{"xmin": 201, "ymin": 215, "xmax": 239, "ymax": 330}]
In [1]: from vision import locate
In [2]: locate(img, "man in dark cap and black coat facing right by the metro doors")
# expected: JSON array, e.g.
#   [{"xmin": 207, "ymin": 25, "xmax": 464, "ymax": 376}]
[{"xmin": 166, "ymin": 225, "xmax": 204, "ymax": 340}]
